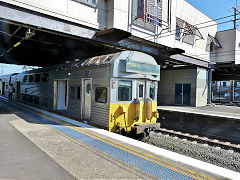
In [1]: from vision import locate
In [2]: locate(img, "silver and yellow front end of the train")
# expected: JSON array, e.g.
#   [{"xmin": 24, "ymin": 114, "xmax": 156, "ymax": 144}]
[{"xmin": 109, "ymin": 51, "xmax": 160, "ymax": 135}]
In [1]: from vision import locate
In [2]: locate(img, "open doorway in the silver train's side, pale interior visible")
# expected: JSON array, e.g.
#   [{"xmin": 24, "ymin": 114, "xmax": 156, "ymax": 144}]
[{"xmin": 54, "ymin": 80, "xmax": 68, "ymax": 110}]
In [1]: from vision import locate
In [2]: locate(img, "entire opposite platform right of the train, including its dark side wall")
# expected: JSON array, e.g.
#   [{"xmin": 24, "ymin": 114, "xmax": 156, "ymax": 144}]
[{"xmin": 158, "ymin": 105, "xmax": 240, "ymax": 143}]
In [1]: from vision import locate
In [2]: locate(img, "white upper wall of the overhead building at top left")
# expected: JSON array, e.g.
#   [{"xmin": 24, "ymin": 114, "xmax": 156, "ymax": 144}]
[{"xmin": 2, "ymin": 0, "xmax": 107, "ymax": 29}]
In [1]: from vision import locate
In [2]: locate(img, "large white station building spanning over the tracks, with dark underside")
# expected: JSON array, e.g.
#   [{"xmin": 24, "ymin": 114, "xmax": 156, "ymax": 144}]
[{"xmin": 0, "ymin": 0, "xmax": 220, "ymax": 106}]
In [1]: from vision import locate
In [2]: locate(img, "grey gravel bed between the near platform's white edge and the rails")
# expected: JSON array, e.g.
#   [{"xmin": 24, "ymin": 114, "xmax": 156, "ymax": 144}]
[{"xmin": 142, "ymin": 132, "xmax": 240, "ymax": 172}]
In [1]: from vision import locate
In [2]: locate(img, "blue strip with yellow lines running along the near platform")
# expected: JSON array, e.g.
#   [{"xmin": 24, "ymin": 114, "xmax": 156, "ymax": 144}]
[{"xmin": 0, "ymin": 99, "xmax": 212, "ymax": 180}]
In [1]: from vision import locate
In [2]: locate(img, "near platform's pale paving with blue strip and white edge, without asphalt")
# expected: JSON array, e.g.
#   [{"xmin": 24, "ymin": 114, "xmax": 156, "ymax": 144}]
[{"xmin": 0, "ymin": 98, "xmax": 240, "ymax": 179}]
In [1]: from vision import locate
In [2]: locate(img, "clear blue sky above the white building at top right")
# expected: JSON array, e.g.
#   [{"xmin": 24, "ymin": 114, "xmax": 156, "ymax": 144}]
[{"xmin": 187, "ymin": 0, "xmax": 240, "ymax": 31}]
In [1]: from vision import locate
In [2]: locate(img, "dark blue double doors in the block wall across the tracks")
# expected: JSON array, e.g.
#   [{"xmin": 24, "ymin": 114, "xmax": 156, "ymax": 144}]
[{"xmin": 175, "ymin": 84, "xmax": 191, "ymax": 105}]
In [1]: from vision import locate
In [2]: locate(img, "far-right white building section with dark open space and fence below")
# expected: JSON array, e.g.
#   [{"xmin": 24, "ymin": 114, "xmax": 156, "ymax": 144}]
[{"xmin": 211, "ymin": 28, "xmax": 240, "ymax": 106}]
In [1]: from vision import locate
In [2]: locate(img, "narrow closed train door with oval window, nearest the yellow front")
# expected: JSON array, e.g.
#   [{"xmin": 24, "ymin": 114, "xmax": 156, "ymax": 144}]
[{"xmin": 82, "ymin": 79, "xmax": 92, "ymax": 119}]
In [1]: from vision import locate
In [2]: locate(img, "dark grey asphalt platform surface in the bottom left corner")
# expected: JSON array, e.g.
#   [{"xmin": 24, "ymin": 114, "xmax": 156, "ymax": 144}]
[{"xmin": 0, "ymin": 102, "xmax": 75, "ymax": 180}]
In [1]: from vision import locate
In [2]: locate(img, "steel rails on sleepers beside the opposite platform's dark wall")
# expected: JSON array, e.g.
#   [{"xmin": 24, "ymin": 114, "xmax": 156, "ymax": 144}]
[{"xmin": 155, "ymin": 128, "xmax": 240, "ymax": 152}]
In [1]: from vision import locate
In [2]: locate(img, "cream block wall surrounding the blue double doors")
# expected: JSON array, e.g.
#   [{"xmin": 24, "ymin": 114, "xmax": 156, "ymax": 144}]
[{"xmin": 158, "ymin": 68, "xmax": 208, "ymax": 107}]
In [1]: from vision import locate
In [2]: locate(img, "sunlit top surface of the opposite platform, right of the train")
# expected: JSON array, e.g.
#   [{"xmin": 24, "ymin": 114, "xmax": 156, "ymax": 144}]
[{"xmin": 157, "ymin": 105, "xmax": 240, "ymax": 120}]
